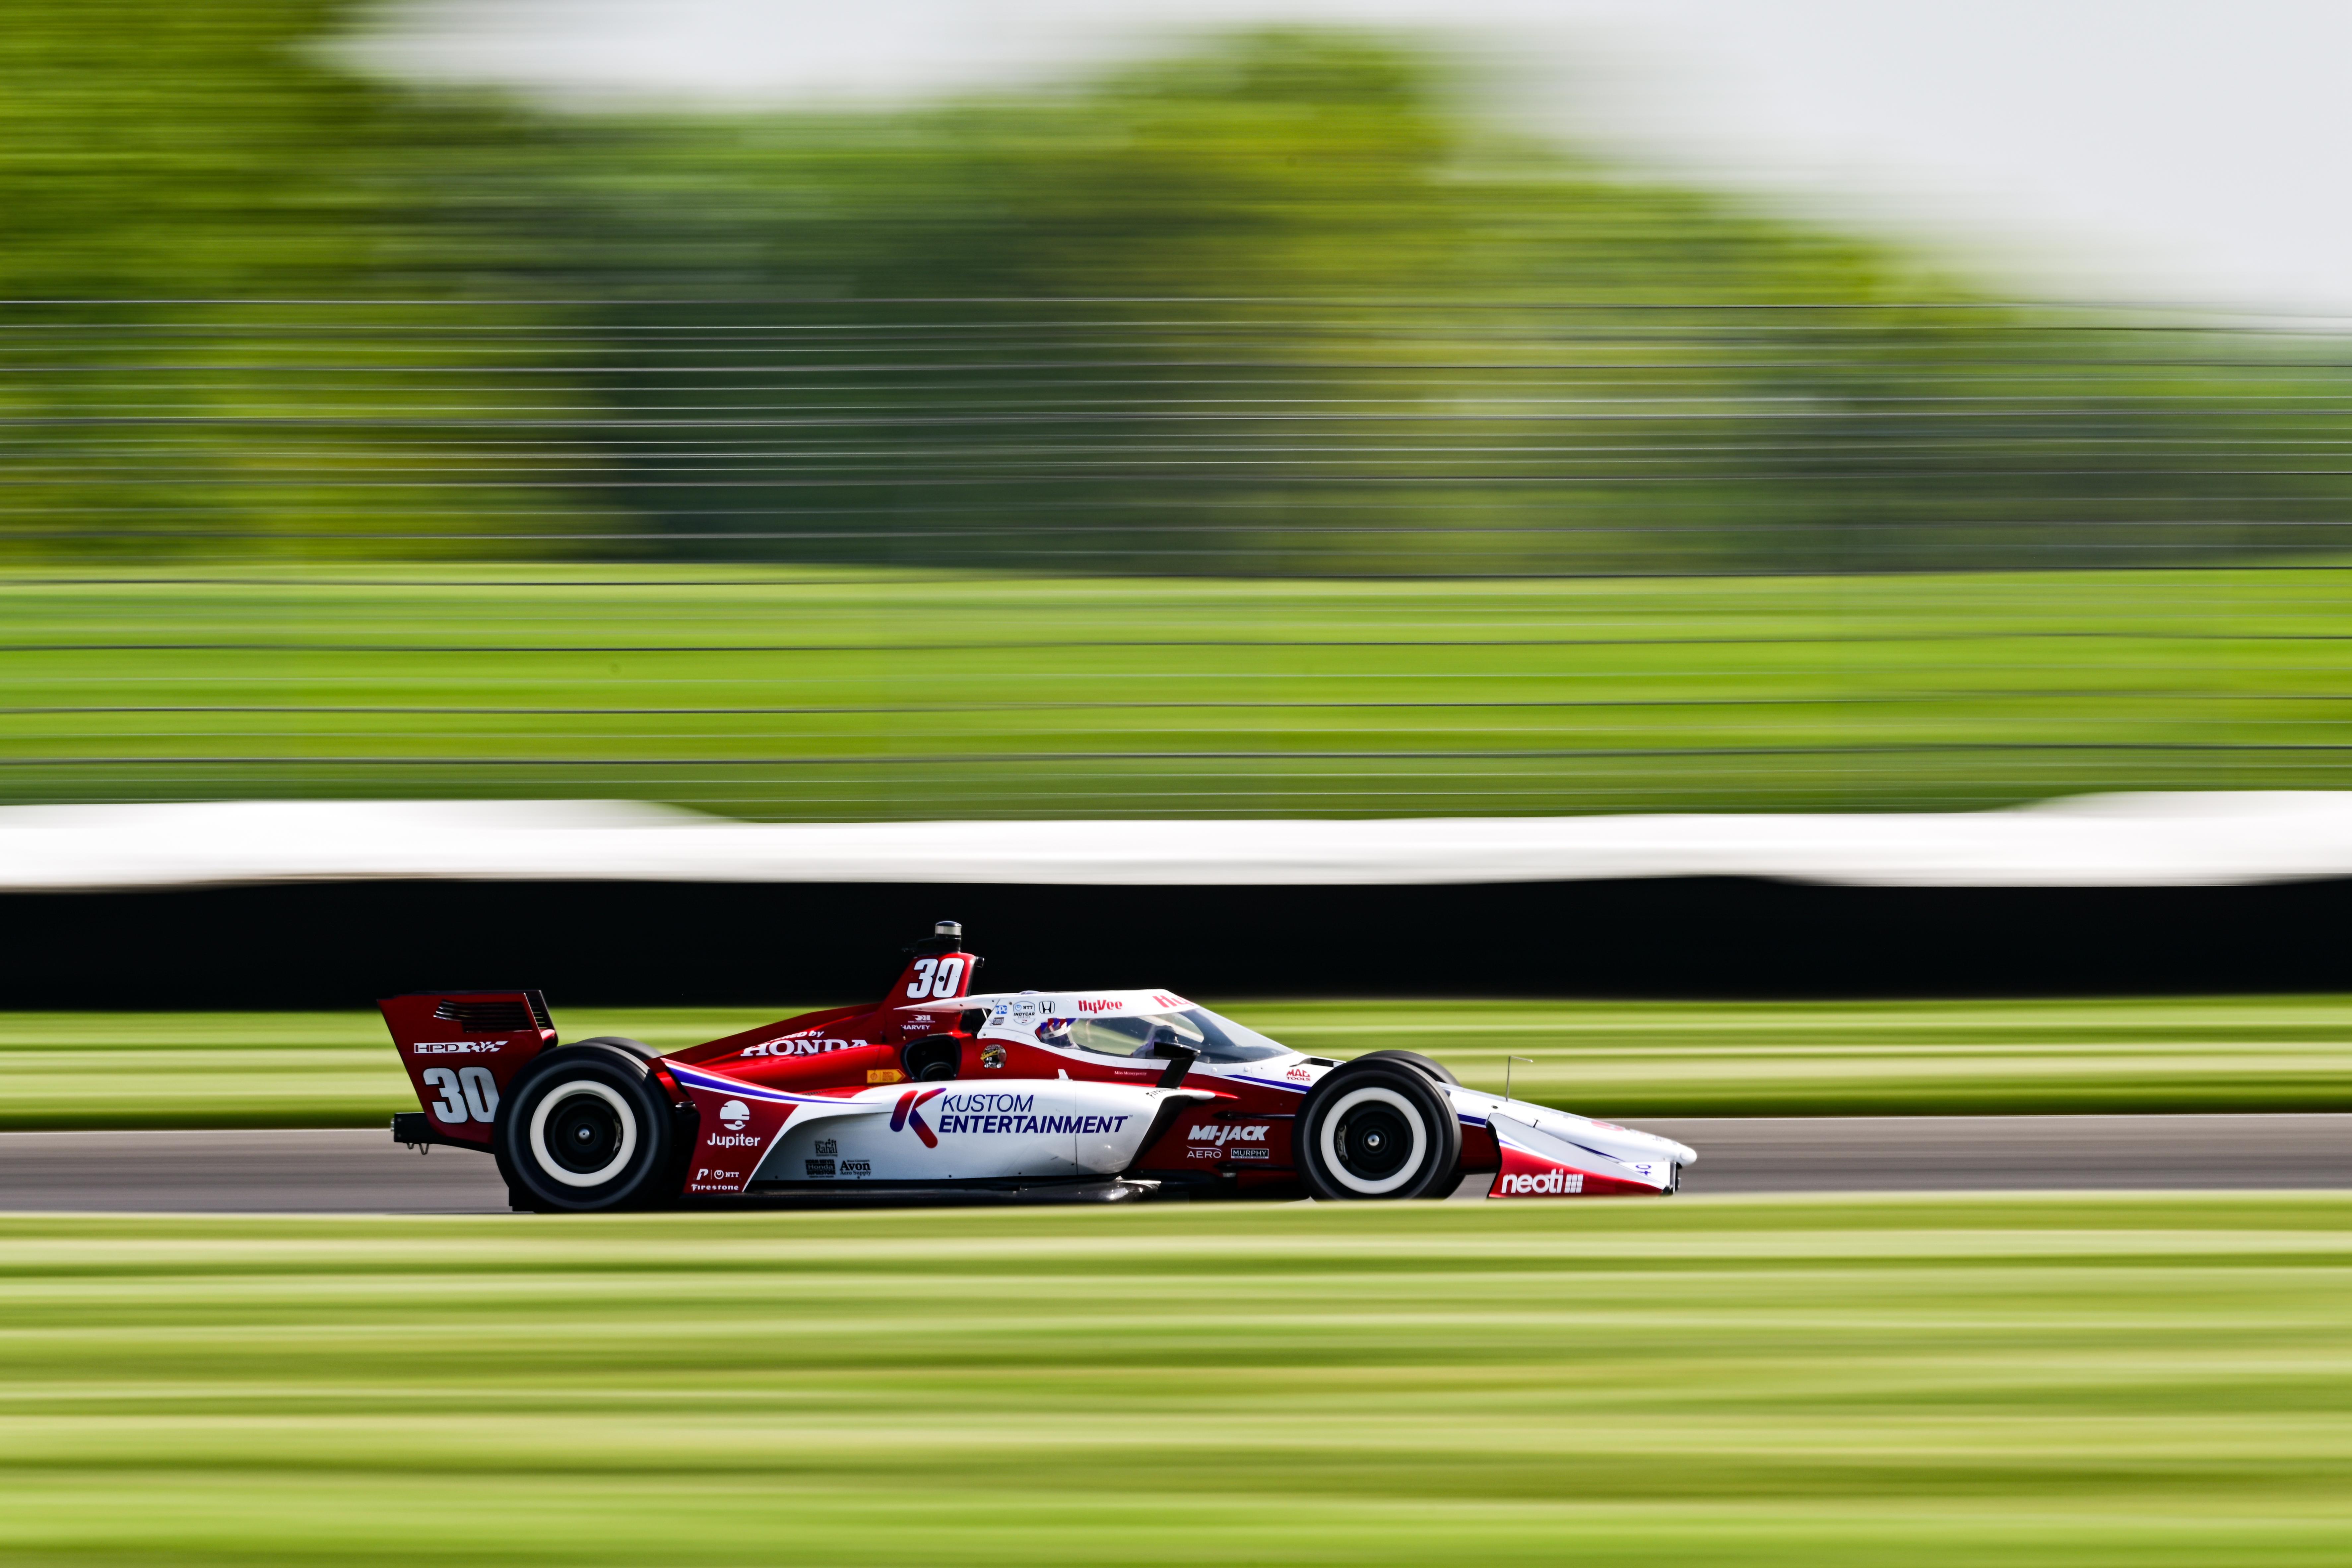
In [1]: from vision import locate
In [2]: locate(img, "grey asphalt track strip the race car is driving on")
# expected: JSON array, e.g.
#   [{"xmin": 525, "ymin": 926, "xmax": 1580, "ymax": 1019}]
[{"xmin": 0, "ymin": 1114, "xmax": 2352, "ymax": 1213}]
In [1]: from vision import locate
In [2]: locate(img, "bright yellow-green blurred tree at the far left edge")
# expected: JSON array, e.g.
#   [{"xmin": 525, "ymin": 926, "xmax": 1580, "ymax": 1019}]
[{"xmin": 0, "ymin": 0, "xmax": 607, "ymax": 555}]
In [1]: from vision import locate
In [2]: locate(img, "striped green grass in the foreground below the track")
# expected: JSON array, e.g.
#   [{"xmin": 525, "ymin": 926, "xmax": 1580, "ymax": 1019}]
[{"xmin": 0, "ymin": 1194, "xmax": 2352, "ymax": 1568}]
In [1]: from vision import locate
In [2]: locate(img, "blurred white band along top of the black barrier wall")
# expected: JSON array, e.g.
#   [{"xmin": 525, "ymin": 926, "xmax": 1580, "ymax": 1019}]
[{"xmin": 14, "ymin": 792, "xmax": 2352, "ymax": 891}]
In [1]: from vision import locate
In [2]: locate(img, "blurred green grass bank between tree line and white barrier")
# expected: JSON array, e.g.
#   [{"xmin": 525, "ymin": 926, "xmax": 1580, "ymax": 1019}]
[{"xmin": 0, "ymin": 564, "xmax": 2352, "ymax": 818}]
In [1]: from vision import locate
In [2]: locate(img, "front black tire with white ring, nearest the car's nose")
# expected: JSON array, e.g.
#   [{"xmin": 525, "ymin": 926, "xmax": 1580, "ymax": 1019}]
[{"xmin": 1291, "ymin": 1058, "xmax": 1463, "ymax": 1204}]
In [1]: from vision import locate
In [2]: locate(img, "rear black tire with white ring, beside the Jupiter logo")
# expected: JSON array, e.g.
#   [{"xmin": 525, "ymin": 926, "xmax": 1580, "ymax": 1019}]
[{"xmin": 489, "ymin": 1039, "xmax": 677, "ymax": 1213}]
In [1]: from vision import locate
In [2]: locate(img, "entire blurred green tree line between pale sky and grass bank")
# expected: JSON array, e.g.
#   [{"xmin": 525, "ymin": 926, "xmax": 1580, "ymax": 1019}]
[{"xmin": 14, "ymin": 12, "xmax": 2352, "ymax": 576}]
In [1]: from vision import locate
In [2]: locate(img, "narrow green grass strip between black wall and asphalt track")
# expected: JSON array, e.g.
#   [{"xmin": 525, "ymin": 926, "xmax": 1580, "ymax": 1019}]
[{"xmin": 0, "ymin": 997, "xmax": 2352, "ymax": 1128}]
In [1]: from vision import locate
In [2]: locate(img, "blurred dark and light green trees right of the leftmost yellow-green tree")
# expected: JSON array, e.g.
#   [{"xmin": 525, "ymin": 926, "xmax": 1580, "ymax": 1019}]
[{"xmin": 522, "ymin": 33, "xmax": 2347, "ymax": 571}]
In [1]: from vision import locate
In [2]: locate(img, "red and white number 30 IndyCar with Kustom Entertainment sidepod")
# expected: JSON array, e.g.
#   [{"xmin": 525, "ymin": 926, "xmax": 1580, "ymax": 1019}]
[{"xmin": 376, "ymin": 922, "xmax": 1698, "ymax": 1211}]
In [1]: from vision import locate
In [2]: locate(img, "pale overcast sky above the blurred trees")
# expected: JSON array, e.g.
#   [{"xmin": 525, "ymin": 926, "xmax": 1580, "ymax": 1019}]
[{"xmin": 367, "ymin": 0, "xmax": 2352, "ymax": 317}]
